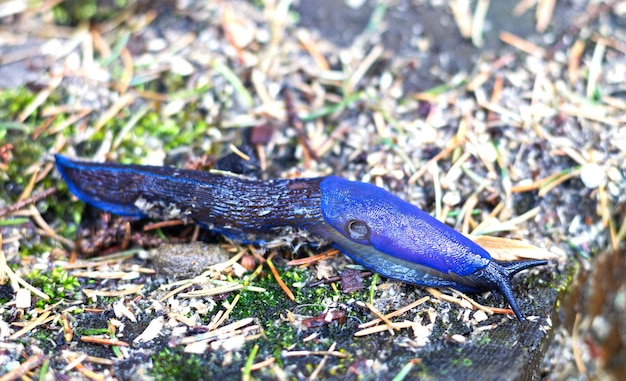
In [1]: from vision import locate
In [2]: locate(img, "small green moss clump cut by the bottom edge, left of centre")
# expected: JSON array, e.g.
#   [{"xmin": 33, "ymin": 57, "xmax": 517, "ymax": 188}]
[{"xmin": 150, "ymin": 348, "xmax": 210, "ymax": 381}]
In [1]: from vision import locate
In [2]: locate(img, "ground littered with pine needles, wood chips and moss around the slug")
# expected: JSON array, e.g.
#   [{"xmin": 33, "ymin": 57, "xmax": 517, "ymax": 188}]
[{"xmin": 0, "ymin": 0, "xmax": 626, "ymax": 381}]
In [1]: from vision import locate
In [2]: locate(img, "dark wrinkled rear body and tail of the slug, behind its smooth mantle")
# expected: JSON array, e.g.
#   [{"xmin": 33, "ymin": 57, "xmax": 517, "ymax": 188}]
[{"xmin": 55, "ymin": 155, "xmax": 324, "ymax": 236}]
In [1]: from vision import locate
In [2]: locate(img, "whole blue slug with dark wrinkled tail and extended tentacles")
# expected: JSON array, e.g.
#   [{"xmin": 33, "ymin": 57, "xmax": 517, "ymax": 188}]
[{"xmin": 56, "ymin": 155, "xmax": 547, "ymax": 321}]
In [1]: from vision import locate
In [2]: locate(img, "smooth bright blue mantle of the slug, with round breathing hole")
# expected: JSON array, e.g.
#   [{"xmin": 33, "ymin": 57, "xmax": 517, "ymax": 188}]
[{"xmin": 320, "ymin": 176, "xmax": 491, "ymax": 276}]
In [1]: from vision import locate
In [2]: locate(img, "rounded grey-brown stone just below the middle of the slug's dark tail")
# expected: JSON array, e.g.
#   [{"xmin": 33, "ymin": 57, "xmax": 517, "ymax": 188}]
[{"xmin": 154, "ymin": 242, "xmax": 230, "ymax": 279}]
